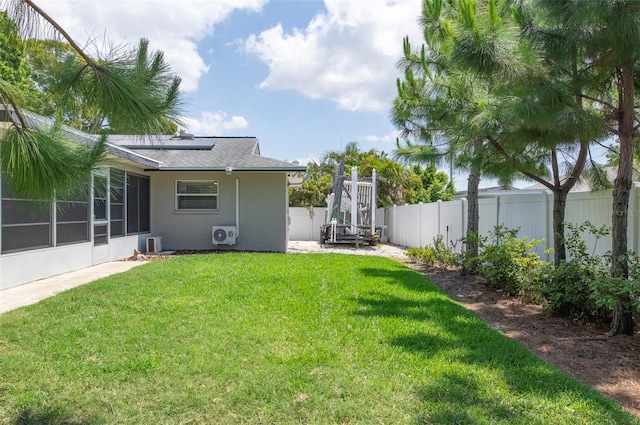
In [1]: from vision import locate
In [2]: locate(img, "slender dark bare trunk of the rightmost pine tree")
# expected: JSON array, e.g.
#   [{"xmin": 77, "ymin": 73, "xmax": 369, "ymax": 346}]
[{"xmin": 609, "ymin": 65, "xmax": 634, "ymax": 335}]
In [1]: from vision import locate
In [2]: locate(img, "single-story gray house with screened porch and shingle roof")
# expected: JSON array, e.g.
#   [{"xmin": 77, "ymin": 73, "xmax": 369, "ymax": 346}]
[{"xmin": 0, "ymin": 109, "xmax": 306, "ymax": 289}]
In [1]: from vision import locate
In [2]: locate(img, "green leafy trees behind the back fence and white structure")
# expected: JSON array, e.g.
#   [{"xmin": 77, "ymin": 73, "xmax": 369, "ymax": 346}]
[{"xmin": 289, "ymin": 142, "xmax": 455, "ymax": 207}]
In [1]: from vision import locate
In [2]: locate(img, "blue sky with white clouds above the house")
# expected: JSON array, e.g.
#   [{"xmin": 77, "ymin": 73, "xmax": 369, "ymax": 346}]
[{"xmin": 38, "ymin": 0, "xmax": 608, "ymax": 190}]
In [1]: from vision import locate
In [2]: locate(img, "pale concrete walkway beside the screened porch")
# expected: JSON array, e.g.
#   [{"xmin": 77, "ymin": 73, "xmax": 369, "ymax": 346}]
[{"xmin": 0, "ymin": 261, "xmax": 145, "ymax": 313}]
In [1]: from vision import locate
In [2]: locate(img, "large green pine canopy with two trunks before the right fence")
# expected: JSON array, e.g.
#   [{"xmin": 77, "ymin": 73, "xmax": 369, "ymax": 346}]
[{"xmin": 392, "ymin": 0, "xmax": 609, "ymax": 264}]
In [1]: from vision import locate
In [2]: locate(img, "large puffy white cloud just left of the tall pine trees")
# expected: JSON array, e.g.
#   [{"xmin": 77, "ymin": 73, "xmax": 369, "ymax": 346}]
[{"xmin": 245, "ymin": 0, "xmax": 421, "ymax": 112}]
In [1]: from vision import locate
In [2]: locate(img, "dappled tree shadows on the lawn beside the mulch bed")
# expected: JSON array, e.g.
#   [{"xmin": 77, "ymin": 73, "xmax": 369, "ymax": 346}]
[{"xmin": 353, "ymin": 268, "xmax": 626, "ymax": 424}]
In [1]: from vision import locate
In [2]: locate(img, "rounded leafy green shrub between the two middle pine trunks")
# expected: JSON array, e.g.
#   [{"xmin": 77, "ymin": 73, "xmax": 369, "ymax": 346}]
[{"xmin": 478, "ymin": 225, "xmax": 549, "ymax": 297}]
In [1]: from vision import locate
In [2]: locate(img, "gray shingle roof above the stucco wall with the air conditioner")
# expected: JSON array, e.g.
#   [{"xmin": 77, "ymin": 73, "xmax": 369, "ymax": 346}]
[{"xmin": 109, "ymin": 136, "xmax": 306, "ymax": 172}]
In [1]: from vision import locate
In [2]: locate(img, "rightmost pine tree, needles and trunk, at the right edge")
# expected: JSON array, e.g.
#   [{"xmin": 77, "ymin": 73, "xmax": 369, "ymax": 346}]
[{"xmin": 530, "ymin": 0, "xmax": 640, "ymax": 335}]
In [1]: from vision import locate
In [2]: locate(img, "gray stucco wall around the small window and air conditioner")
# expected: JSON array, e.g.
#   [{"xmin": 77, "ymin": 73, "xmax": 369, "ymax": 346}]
[{"xmin": 151, "ymin": 172, "xmax": 288, "ymax": 252}]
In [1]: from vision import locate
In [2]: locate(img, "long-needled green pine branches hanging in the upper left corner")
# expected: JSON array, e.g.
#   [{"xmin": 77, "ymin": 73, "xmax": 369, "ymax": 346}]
[{"xmin": 0, "ymin": 0, "xmax": 180, "ymax": 200}]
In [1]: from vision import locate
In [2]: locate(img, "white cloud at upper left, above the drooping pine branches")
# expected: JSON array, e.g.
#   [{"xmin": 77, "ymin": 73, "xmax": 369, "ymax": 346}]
[{"xmin": 40, "ymin": 0, "xmax": 268, "ymax": 92}]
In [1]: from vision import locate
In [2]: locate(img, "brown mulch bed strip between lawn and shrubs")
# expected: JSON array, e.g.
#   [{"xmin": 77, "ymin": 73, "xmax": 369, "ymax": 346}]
[{"xmin": 407, "ymin": 263, "xmax": 640, "ymax": 417}]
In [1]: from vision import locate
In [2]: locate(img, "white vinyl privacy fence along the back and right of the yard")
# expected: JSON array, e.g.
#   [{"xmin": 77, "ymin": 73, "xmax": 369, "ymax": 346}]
[{"xmin": 289, "ymin": 183, "xmax": 640, "ymax": 259}]
